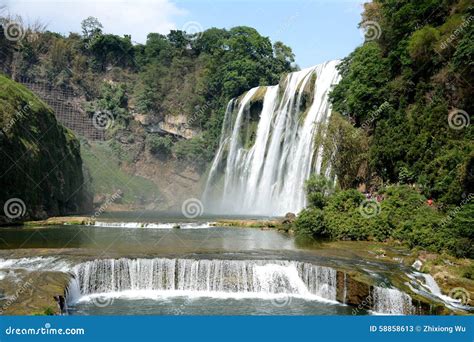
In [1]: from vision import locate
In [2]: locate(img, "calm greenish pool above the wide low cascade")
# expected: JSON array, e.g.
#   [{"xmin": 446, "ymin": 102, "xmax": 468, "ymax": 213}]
[{"xmin": 0, "ymin": 226, "xmax": 297, "ymax": 254}]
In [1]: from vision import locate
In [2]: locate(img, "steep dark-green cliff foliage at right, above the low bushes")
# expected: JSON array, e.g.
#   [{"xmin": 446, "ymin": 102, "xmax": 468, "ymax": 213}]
[{"xmin": 331, "ymin": 0, "xmax": 474, "ymax": 207}]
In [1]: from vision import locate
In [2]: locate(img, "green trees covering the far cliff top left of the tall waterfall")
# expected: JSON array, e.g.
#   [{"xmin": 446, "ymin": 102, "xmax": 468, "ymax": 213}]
[{"xmin": 0, "ymin": 17, "xmax": 294, "ymax": 169}]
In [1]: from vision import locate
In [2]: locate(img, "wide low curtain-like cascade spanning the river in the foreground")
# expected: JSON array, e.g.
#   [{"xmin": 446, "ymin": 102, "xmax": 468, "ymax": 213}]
[{"xmin": 68, "ymin": 258, "xmax": 336, "ymax": 302}]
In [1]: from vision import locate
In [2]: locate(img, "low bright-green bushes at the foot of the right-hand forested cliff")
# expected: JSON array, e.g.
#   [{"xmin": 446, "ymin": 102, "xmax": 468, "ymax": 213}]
[{"xmin": 294, "ymin": 178, "xmax": 474, "ymax": 258}]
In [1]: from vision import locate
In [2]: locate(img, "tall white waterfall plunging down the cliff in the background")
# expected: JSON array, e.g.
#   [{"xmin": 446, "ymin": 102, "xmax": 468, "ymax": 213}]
[{"xmin": 203, "ymin": 61, "xmax": 339, "ymax": 216}]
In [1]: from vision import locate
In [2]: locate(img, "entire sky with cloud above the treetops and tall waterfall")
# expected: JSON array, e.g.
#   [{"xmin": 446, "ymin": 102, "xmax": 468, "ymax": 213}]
[{"xmin": 0, "ymin": 0, "xmax": 364, "ymax": 68}]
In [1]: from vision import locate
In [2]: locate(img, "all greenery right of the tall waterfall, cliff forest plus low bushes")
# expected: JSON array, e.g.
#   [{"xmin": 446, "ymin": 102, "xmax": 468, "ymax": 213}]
[{"xmin": 296, "ymin": 0, "xmax": 474, "ymax": 257}]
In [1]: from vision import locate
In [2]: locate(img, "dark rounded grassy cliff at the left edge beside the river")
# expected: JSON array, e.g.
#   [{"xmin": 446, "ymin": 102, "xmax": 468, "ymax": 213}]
[{"xmin": 0, "ymin": 75, "xmax": 92, "ymax": 224}]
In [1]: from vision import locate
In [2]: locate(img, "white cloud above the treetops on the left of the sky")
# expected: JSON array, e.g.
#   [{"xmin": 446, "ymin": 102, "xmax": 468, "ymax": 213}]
[{"xmin": 0, "ymin": 0, "xmax": 187, "ymax": 43}]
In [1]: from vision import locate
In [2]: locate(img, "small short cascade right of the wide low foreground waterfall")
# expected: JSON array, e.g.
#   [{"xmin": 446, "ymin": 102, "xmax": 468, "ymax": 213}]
[{"xmin": 373, "ymin": 286, "xmax": 413, "ymax": 315}]
